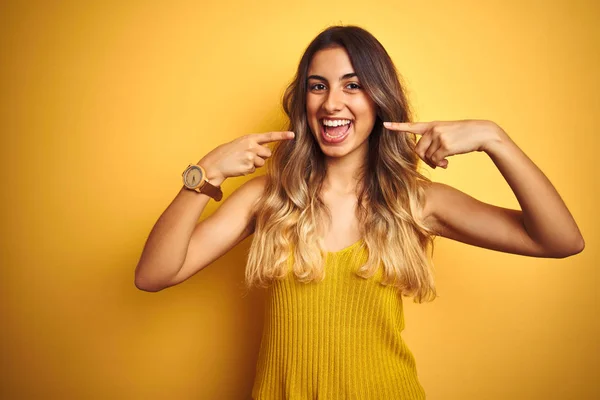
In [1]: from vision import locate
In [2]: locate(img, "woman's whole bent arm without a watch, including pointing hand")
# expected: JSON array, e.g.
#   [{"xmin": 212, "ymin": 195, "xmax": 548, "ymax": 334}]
[{"xmin": 386, "ymin": 120, "xmax": 585, "ymax": 258}]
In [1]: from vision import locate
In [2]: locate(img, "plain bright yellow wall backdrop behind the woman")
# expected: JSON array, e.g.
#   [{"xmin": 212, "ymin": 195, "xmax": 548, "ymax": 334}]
[{"xmin": 0, "ymin": 0, "xmax": 600, "ymax": 399}]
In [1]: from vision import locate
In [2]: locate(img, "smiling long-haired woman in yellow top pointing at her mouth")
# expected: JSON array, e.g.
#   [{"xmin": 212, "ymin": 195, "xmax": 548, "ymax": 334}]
[{"xmin": 136, "ymin": 26, "xmax": 584, "ymax": 399}]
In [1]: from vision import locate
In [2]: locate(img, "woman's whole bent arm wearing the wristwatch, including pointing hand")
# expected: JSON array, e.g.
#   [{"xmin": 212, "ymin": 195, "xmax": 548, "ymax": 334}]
[{"xmin": 135, "ymin": 132, "xmax": 291, "ymax": 292}]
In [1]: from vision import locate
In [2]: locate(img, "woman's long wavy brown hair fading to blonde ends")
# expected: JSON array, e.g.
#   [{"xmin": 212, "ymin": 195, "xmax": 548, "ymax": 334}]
[{"xmin": 245, "ymin": 26, "xmax": 436, "ymax": 303}]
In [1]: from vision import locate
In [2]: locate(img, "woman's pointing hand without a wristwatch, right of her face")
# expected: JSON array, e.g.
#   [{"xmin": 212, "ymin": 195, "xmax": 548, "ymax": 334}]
[{"xmin": 384, "ymin": 120, "xmax": 506, "ymax": 169}]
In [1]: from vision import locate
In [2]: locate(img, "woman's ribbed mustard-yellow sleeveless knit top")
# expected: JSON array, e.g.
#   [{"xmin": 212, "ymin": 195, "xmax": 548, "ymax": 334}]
[{"xmin": 252, "ymin": 240, "xmax": 425, "ymax": 400}]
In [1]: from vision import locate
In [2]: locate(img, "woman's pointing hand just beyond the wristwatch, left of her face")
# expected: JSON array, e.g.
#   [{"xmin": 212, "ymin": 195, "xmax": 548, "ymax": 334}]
[{"xmin": 198, "ymin": 131, "xmax": 294, "ymax": 181}]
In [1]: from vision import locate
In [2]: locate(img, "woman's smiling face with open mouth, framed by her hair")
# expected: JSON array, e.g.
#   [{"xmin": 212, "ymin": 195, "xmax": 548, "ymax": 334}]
[{"xmin": 306, "ymin": 47, "xmax": 376, "ymax": 157}]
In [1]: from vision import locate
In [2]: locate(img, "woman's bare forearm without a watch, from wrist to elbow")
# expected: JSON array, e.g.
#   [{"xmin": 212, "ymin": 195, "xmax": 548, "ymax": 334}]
[{"xmin": 484, "ymin": 127, "xmax": 584, "ymax": 254}]
